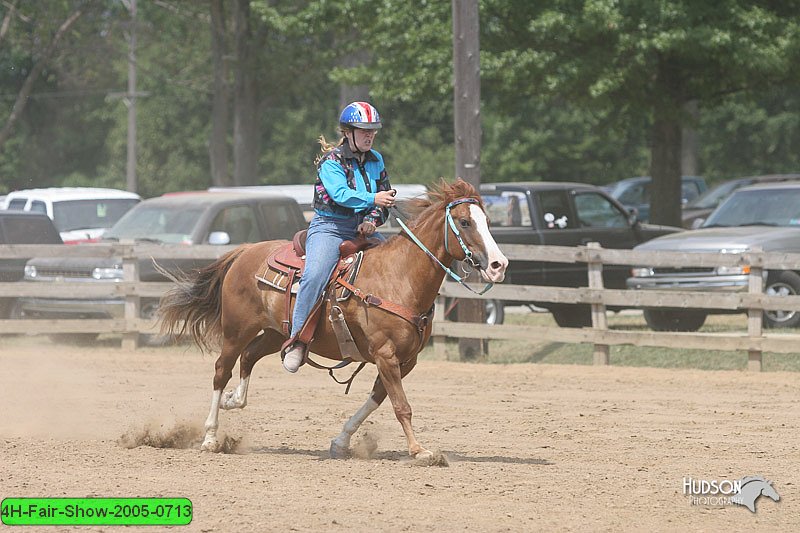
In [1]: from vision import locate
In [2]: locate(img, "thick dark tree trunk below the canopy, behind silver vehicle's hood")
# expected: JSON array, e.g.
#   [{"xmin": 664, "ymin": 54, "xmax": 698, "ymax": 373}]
[{"xmin": 650, "ymin": 115, "xmax": 681, "ymax": 227}]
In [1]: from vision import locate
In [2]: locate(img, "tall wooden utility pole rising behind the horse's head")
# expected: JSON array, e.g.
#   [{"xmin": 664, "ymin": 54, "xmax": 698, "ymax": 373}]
[{"xmin": 452, "ymin": 0, "xmax": 486, "ymax": 361}]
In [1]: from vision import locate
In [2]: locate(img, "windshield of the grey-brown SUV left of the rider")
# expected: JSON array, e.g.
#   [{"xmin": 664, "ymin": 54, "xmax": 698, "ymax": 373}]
[{"xmin": 103, "ymin": 204, "xmax": 203, "ymax": 243}]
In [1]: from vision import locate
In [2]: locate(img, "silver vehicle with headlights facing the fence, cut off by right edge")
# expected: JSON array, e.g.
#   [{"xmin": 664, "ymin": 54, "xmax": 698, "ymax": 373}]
[{"xmin": 627, "ymin": 182, "xmax": 800, "ymax": 331}]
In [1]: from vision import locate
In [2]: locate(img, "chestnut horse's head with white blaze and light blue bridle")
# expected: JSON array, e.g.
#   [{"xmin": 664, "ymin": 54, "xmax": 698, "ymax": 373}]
[{"xmin": 438, "ymin": 179, "xmax": 508, "ymax": 283}]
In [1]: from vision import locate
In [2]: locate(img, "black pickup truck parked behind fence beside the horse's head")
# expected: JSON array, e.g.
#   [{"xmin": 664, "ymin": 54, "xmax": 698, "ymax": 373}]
[{"xmin": 481, "ymin": 182, "xmax": 682, "ymax": 327}]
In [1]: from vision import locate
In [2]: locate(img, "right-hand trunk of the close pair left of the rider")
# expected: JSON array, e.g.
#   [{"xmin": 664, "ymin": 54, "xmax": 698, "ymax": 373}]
[{"xmin": 233, "ymin": 0, "xmax": 261, "ymax": 185}]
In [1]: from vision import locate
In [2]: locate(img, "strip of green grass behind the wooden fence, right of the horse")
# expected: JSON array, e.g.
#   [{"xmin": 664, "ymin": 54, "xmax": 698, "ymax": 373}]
[{"xmin": 421, "ymin": 312, "xmax": 800, "ymax": 372}]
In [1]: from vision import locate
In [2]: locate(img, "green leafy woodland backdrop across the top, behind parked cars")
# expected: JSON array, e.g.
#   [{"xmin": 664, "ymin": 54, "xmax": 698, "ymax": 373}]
[{"xmin": 0, "ymin": 0, "xmax": 800, "ymax": 200}]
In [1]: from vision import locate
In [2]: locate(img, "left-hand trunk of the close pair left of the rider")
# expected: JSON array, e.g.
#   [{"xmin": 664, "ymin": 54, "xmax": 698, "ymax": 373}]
[{"xmin": 208, "ymin": 0, "xmax": 233, "ymax": 187}]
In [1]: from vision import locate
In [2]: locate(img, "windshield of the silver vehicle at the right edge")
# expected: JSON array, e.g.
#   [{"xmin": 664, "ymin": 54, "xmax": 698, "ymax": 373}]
[{"xmin": 702, "ymin": 188, "xmax": 800, "ymax": 228}]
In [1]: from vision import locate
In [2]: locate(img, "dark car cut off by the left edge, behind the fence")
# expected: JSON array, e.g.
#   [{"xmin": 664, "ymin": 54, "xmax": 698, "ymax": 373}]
[{"xmin": 0, "ymin": 210, "xmax": 63, "ymax": 319}]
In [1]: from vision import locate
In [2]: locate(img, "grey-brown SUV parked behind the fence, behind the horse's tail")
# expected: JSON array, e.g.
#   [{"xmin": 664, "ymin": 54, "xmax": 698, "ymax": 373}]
[{"xmin": 20, "ymin": 191, "xmax": 306, "ymax": 340}]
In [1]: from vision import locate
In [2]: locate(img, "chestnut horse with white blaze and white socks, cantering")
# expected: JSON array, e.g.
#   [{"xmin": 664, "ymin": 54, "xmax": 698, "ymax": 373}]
[{"xmin": 159, "ymin": 179, "xmax": 508, "ymax": 459}]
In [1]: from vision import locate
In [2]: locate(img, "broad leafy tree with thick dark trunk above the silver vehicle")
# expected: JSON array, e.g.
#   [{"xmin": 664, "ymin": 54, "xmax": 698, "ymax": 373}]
[{"xmin": 483, "ymin": 0, "xmax": 800, "ymax": 225}]
